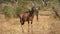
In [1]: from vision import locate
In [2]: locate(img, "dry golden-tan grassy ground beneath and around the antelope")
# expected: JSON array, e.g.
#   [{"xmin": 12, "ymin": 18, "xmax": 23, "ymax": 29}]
[{"xmin": 0, "ymin": 11, "xmax": 60, "ymax": 34}]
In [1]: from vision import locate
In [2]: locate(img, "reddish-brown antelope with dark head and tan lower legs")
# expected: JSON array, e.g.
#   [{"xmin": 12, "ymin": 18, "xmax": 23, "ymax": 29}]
[{"xmin": 18, "ymin": 7, "xmax": 39, "ymax": 32}]
